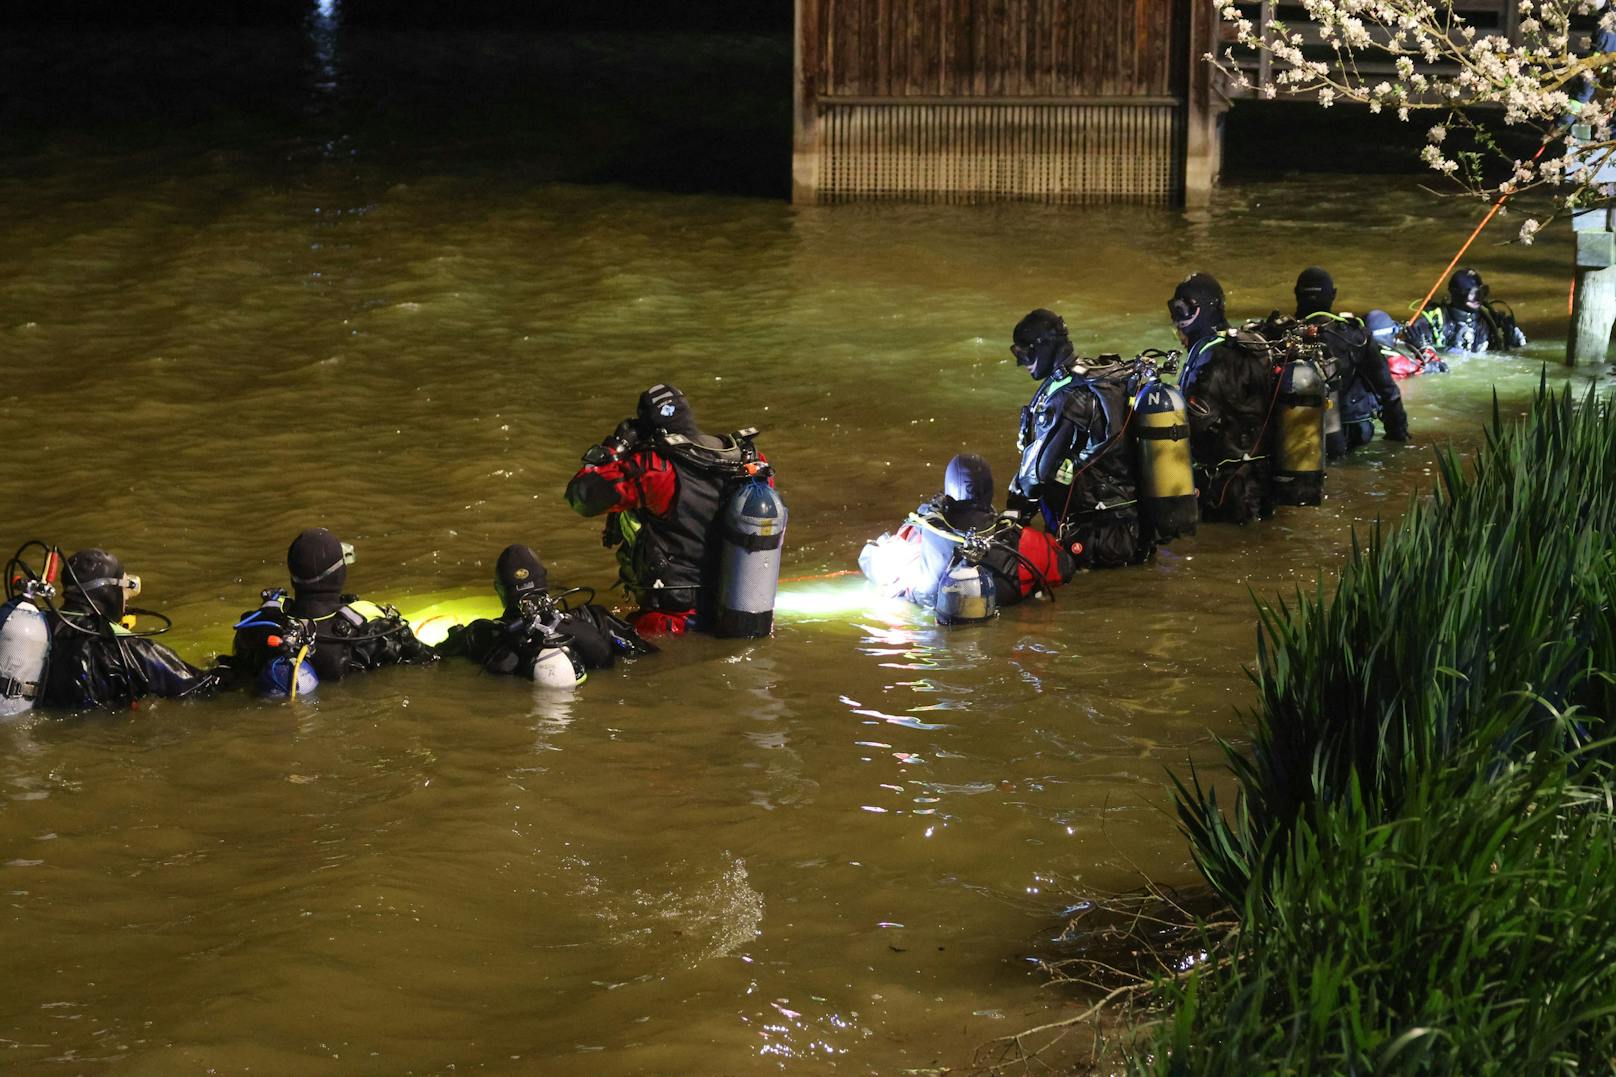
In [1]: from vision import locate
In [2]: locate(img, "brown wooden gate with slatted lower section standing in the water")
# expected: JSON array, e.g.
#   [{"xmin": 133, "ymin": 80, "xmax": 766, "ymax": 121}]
[{"xmin": 792, "ymin": 0, "xmax": 1214, "ymax": 202}]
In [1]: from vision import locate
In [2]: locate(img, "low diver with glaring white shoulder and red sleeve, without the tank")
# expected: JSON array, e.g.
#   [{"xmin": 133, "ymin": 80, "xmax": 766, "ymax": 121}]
[{"xmin": 858, "ymin": 453, "xmax": 1078, "ymax": 608}]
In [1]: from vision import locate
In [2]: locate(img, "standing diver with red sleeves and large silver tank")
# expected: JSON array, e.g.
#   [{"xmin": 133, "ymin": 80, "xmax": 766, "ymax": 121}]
[{"xmin": 566, "ymin": 385, "xmax": 787, "ymax": 637}]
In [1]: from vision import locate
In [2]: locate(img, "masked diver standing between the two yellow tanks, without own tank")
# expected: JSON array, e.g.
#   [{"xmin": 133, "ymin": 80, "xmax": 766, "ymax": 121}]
[{"xmin": 1167, "ymin": 273, "xmax": 1277, "ymax": 524}]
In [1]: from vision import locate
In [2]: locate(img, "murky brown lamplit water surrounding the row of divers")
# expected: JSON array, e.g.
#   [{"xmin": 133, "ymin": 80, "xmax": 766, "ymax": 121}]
[{"xmin": 0, "ymin": 18, "xmax": 1596, "ymax": 1074}]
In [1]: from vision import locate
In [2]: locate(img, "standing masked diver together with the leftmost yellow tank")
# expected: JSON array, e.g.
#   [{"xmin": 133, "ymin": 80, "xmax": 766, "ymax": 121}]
[{"xmin": 1005, "ymin": 309, "xmax": 1194, "ymax": 569}]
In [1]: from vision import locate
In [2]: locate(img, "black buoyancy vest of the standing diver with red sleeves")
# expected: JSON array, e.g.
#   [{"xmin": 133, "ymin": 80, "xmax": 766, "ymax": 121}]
[{"xmin": 608, "ymin": 429, "xmax": 761, "ymax": 623}]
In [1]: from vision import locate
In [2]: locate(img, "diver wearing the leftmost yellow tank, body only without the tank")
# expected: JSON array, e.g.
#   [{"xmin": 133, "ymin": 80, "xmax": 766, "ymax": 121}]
[{"xmin": 1007, "ymin": 309, "xmax": 1155, "ymax": 568}]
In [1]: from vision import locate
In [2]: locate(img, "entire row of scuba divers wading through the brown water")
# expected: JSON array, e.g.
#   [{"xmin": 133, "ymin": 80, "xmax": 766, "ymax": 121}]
[{"xmin": 0, "ymin": 267, "xmax": 1526, "ymax": 715}]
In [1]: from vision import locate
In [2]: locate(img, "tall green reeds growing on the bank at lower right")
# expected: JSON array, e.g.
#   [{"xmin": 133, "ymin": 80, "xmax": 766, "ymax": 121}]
[{"xmin": 1126, "ymin": 381, "xmax": 1616, "ymax": 1074}]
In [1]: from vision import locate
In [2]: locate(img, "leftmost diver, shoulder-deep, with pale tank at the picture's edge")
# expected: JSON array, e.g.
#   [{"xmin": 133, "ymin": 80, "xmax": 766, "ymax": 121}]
[{"xmin": 0, "ymin": 542, "xmax": 225, "ymax": 716}]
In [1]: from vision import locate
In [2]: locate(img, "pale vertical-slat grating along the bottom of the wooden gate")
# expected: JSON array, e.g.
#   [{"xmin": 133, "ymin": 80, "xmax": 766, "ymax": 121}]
[{"xmin": 818, "ymin": 100, "xmax": 1183, "ymax": 202}]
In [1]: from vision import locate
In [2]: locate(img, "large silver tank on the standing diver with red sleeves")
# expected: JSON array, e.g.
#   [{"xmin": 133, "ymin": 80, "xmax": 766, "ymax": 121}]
[{"xmin": 714, "ymin": 472, "xmax": 789, "ymax": 639}]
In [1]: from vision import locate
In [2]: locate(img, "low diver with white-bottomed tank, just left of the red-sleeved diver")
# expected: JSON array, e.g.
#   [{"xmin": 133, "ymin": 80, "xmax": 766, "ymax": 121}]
[{"xmin": 438, "ymin": 545, "xmax": 656, "ymax": 686}]
